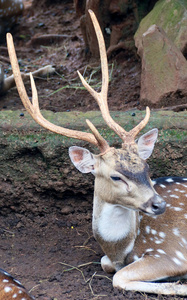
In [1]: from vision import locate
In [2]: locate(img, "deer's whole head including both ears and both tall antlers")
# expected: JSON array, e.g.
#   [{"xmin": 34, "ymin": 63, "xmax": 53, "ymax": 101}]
[{"xmin": 7, "ymin": 11, "xmax": 165, "ymax": 214}]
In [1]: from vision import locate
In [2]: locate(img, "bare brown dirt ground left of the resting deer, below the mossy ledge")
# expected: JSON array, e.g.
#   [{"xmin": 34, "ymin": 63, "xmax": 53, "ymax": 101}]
[{"xmin": 0, "ymin": 196, "xmax": 186, "ymax": 300}]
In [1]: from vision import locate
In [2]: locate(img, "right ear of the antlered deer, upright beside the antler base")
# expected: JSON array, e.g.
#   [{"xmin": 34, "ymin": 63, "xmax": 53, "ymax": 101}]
[{"xmin": 138, "ymin": 128, "xmax": 158, "ymax": 160}]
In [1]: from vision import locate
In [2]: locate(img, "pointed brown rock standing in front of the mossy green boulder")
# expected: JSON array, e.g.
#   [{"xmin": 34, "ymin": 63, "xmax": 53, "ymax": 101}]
[{"xmin": 138, "ymin": 25, "xmax": 187, "ymax": 107}]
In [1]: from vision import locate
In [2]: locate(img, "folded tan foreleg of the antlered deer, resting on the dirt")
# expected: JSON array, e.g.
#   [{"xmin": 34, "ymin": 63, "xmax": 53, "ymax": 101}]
[{"xmin": 113, "ymin": 256, "xmax": 187, "ymax": 296}]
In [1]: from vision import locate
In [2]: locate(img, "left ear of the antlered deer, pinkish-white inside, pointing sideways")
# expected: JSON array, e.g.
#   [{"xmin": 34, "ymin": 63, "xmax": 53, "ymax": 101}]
[{"xmin": 69, "ymin": 146, "xmax": 95, "ymax": 173}]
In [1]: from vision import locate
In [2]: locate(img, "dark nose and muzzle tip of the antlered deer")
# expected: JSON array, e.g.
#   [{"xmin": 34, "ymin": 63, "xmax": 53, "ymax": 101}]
[{"xmin": 142, "ymin": 195, "xmax": 166, "ymax": 215}]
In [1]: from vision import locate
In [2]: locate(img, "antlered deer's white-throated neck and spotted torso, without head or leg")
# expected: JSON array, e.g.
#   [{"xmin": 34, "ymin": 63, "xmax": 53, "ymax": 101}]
[{"xmin": 93, "ymin": 178, "xmax": 187, "ymax": 274}]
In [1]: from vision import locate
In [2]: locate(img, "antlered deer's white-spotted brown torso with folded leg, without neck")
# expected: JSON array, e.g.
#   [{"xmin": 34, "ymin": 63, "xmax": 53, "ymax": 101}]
[{"xmin": 113, "ymin": 178, "xmax": 187, "ymax": 295}]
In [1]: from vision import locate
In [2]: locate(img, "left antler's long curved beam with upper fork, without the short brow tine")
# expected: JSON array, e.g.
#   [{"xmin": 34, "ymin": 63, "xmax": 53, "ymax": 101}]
[{"xmin": 7, "ymin": 33, "xmax": 109, "ymax": 152}]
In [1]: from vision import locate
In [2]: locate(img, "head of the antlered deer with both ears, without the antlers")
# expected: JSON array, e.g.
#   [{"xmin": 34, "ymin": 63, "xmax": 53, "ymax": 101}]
[{"xmin": 69, "ymin": 129, "xmax": 165, "ymax": 214}]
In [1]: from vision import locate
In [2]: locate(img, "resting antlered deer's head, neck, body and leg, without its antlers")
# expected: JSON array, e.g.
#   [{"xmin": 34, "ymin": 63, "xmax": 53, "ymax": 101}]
[{"xmin": 70, "ymin": 142, "xmax": 187, "ymax": 295}]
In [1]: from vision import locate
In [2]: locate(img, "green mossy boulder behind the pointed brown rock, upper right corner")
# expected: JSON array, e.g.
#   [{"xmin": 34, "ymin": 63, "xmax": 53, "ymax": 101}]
[{"xmin": 134, "ymin": 0, "xmax": 187, "ymax": 56}]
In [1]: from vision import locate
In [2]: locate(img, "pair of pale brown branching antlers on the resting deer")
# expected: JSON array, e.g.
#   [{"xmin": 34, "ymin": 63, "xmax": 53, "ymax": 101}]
[{"xmin": 7, "ymin": 10, "xmax": 150, "ymax": 153}]
